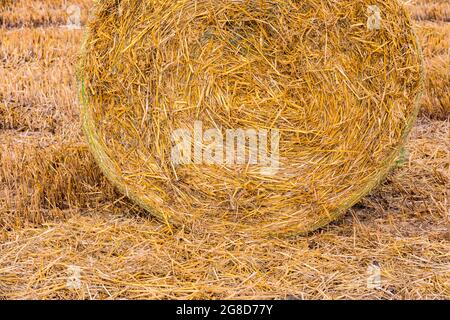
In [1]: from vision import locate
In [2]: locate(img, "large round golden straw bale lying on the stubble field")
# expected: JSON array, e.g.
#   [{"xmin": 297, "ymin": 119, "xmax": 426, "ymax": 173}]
[{"xmin": 80, "ymin": 0, "xmax": 423, "ymax": 235}]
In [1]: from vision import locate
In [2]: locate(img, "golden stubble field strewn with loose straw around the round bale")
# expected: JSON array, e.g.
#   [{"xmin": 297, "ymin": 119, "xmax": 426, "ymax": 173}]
[{"xmin": 0, "ymin": 0, "xmax": 450, "ymax": 299}]
